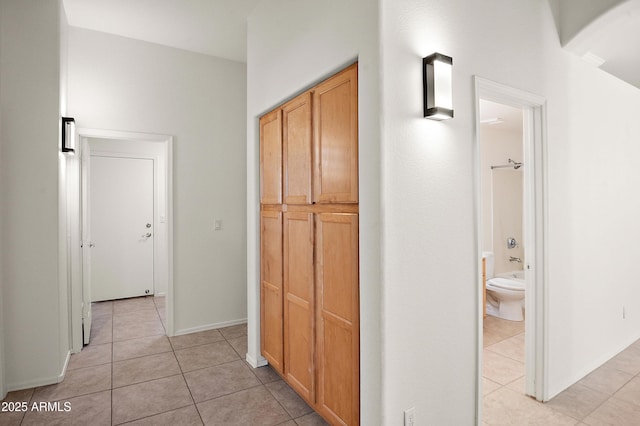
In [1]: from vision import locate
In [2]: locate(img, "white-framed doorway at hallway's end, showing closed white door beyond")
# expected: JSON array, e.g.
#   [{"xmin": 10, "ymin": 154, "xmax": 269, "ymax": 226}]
[{"xmin": 72, "ymin": 129, "xmax": 173, "ymax": 345}]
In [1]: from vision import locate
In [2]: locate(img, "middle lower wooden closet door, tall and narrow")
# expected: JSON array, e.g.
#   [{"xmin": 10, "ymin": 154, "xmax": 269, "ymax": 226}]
[{"xmin": 284, "ymin": 212, "xmax": 315, "ymax": 402}]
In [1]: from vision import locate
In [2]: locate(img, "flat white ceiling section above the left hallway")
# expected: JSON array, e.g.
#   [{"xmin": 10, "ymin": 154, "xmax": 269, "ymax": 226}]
[{"xmin": 63, "ymin": 0, "xmax": 260, "ymax": 62}]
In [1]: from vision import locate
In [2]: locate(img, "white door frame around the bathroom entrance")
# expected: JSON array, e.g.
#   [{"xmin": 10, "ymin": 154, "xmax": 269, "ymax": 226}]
[{"xmin": 474, "ymin": 76, "xmax": 548, "ymax": 412}]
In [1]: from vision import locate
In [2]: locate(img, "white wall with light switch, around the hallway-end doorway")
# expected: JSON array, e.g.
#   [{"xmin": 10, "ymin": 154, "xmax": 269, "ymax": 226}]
[{"xmin": 68, "ymin": 27, "xmax": 247, "ymax": 333}]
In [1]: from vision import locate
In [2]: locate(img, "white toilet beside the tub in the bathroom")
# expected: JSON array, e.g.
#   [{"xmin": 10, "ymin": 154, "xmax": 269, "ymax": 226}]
[{"xmin": 482, "ymin": 252, "xmax": 525, "ymax": 321}]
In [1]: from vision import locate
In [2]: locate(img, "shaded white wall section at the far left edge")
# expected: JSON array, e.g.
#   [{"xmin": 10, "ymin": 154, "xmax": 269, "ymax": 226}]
[{"xmin": 0, "ymin": 0, "xmax": 69, "ymax": 389}]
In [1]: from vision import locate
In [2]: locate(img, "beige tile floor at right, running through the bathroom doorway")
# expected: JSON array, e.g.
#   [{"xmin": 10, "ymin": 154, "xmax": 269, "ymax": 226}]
[{"xmin": 482, "ymin": 315, "xmax": 640, "ymax": 426}]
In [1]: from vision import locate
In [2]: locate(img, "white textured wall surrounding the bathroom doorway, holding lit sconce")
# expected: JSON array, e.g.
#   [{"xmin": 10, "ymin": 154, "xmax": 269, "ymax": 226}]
[{"xmin": 381, "ymin": 0, "xmax": 640, "ymax": 424}]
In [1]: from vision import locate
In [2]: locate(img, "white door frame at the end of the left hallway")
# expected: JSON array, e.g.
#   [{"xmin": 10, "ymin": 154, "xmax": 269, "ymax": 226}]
[{"xmin": 71, "ymin": 128, "xmax": 174, "ymax": 349}]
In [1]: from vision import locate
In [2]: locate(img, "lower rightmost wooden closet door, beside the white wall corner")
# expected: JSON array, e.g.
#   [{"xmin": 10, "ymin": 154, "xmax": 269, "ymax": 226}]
[{"xmin": 316, "ymin": 213, "xmax": 360, "ymax": 425}]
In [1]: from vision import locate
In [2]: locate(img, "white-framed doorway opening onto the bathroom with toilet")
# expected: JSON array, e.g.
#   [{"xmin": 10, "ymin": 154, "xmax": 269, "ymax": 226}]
[{"xmin": 475, "ymin": 77, "xmax": 546, "ymax": 412}]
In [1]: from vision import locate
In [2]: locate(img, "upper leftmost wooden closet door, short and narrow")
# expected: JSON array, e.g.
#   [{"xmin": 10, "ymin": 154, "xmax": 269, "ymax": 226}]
[{"xmin": 260, "ymin": 109, "xmax": 282, "ymax": 204}]
